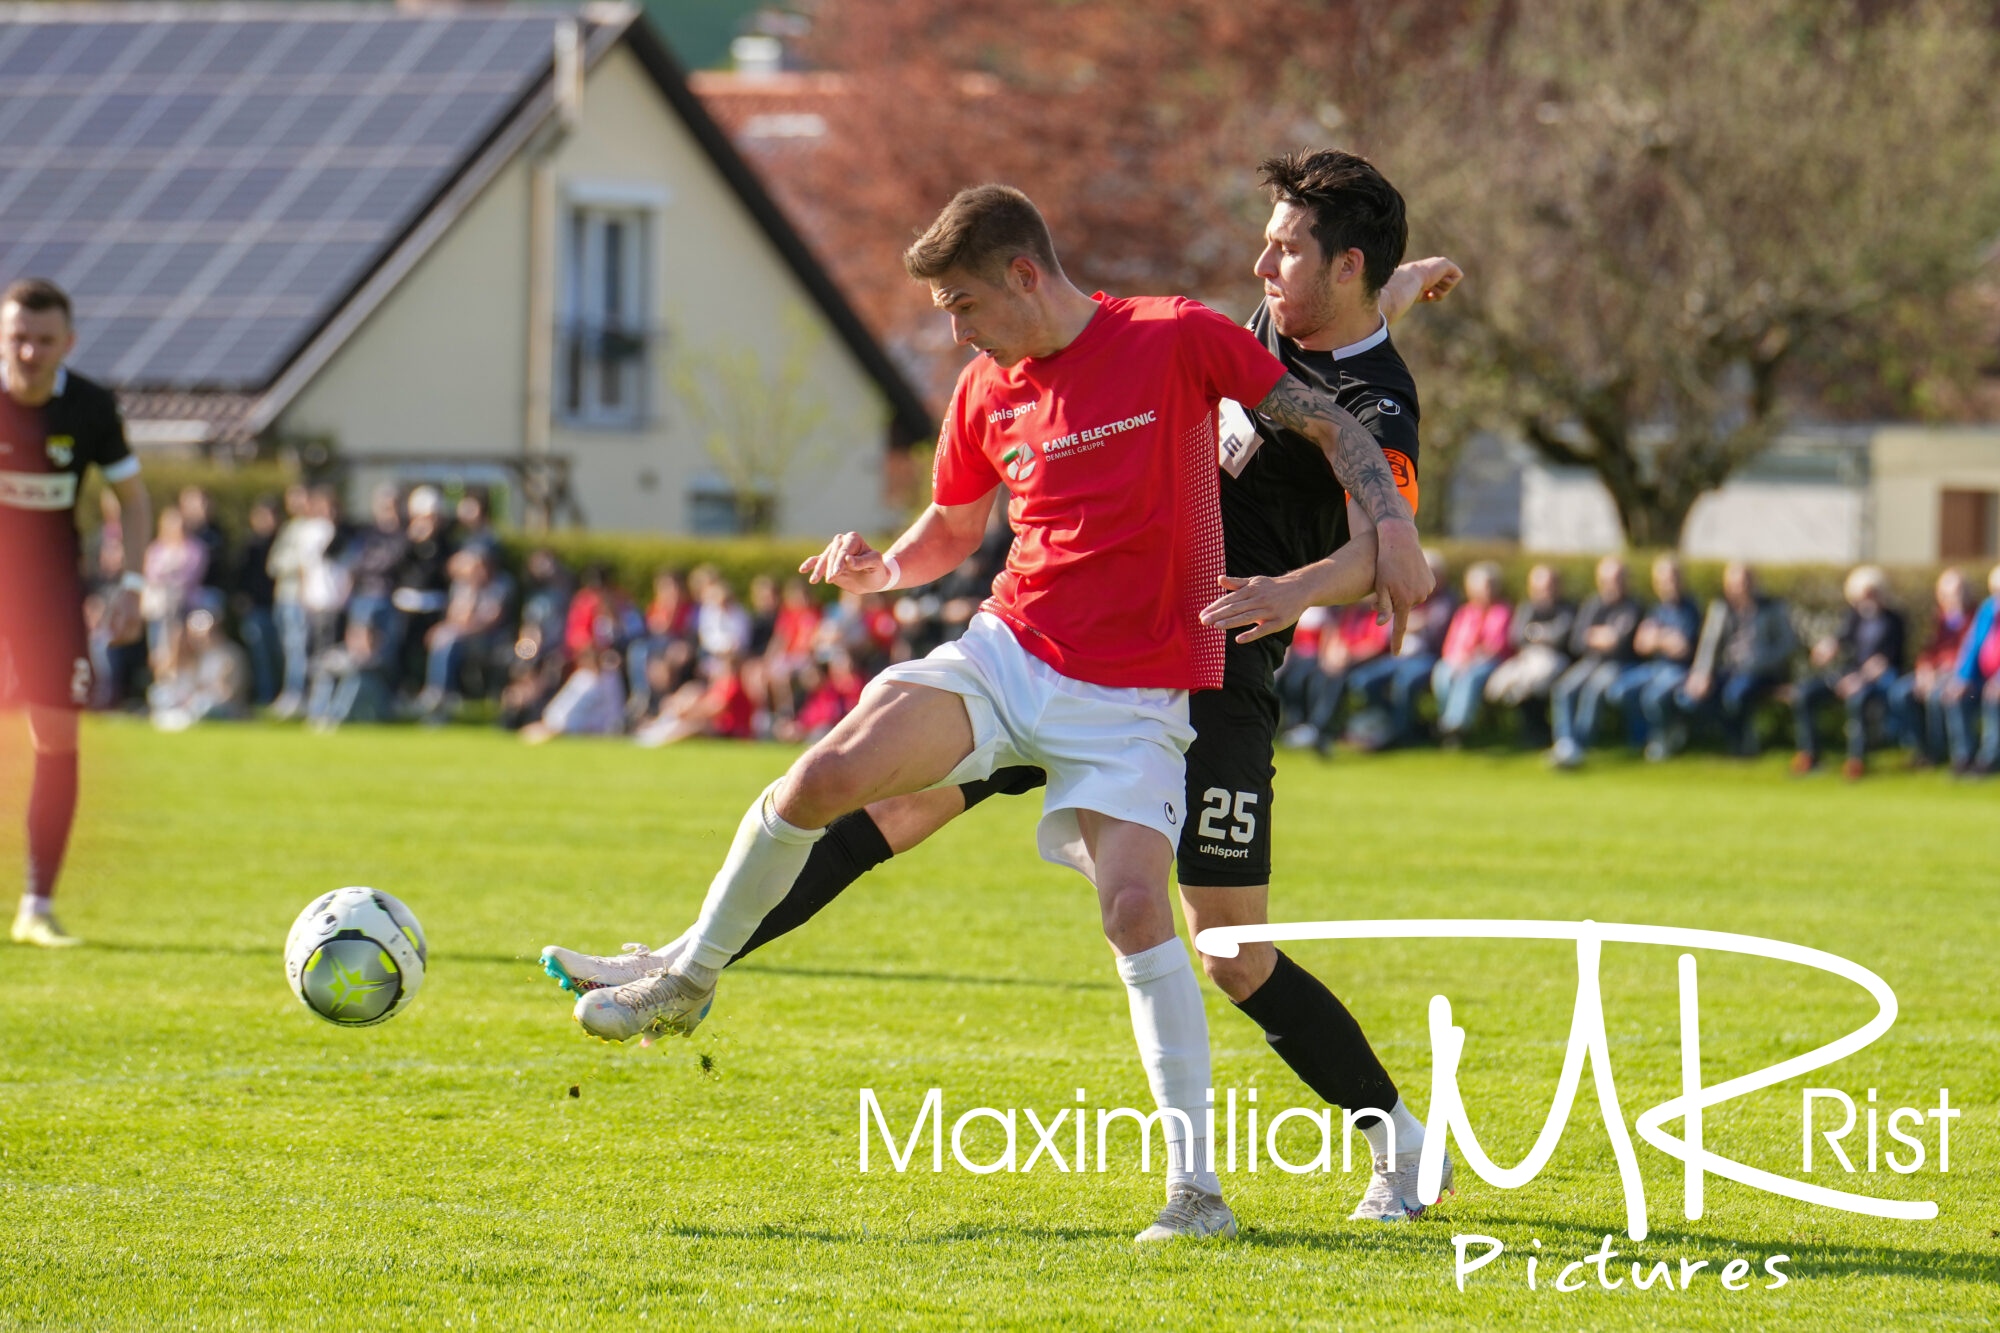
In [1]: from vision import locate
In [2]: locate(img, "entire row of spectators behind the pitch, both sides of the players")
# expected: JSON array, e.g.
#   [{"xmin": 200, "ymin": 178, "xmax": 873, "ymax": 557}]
[{"xmin": 86, "ymin": 484, "xmax": 2000, "ymax": 779}]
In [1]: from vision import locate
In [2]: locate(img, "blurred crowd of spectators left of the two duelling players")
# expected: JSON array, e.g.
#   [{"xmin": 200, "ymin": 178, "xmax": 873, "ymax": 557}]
[{"xmin": 86, "ymin": 484, "xmax": 1006, "ymax": 745}]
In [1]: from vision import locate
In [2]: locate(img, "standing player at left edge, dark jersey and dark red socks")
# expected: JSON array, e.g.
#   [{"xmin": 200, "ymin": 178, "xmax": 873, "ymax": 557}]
[{"xmin": 0, "ymin": 278, "xmax": 152, "ymax": 949}]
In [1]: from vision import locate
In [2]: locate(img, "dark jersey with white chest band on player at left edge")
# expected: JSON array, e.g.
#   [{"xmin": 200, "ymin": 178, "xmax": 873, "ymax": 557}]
[{"xmin": 0, "ymin": 360, "xmax": 138, "ymax": 596}]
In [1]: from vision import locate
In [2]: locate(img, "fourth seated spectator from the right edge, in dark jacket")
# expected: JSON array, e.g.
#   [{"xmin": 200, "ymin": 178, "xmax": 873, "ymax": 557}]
[{"xmin": 1648, "ymin": 562, "xmax": 1796, "ymax": 759}]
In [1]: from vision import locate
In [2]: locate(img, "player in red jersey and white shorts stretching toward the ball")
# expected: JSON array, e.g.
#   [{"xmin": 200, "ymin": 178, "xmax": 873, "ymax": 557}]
[{"xmin": 556, "ymin": 186, "xmax": 1430, "ymax": 1241}]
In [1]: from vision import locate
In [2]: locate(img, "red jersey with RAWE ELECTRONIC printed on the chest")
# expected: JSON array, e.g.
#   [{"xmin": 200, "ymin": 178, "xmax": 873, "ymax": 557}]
[{"xmin": 932, "ymin": 292, "xmax": 1286, "ymax": 691}]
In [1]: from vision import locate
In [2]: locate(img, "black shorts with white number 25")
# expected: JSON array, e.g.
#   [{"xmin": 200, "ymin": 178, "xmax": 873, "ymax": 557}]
[{"xmin": 1176, "ymin": 689, "xmax": 1278, "ymax": 889}]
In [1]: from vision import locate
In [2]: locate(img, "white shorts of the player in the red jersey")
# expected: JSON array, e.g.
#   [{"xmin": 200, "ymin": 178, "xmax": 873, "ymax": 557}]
[{"xmin": 876, "ymin": 610, "xmax": 1194, "ymax": 883}]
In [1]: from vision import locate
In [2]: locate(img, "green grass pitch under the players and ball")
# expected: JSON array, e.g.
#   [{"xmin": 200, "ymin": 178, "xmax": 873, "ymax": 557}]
[{"xmin": 0, "ymin": 719, "xmax": 2000, "ymax": 1329}]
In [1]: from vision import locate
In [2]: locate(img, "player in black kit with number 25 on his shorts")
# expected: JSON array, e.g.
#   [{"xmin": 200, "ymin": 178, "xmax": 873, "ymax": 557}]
[{"xmin": 542, "ymin": 150, "xmax": 1460, "ymax": 1221}]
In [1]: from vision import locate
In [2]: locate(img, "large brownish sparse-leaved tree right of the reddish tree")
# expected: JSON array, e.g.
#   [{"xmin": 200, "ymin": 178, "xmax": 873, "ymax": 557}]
[{"xmin": 1362, "ymin": 0, "xmax": 2000, "ymax": 546}]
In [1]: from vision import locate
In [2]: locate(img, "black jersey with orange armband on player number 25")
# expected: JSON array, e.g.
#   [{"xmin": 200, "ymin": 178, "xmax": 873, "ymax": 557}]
[{"xmin": 1222, "ymin": 306, "xmax": 1418, "ymax": 689}]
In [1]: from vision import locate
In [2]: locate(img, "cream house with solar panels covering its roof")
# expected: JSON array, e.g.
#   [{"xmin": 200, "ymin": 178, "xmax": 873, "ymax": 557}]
[{"xmin": 0, "ymin": 4, "xmax": 934, "ymax": 534}]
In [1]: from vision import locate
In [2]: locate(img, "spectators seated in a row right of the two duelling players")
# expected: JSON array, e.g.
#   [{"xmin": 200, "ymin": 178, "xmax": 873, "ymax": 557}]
[{"xmin": 1278, "ymin": 556, "xmax": 2000, "ymax": 779}]
